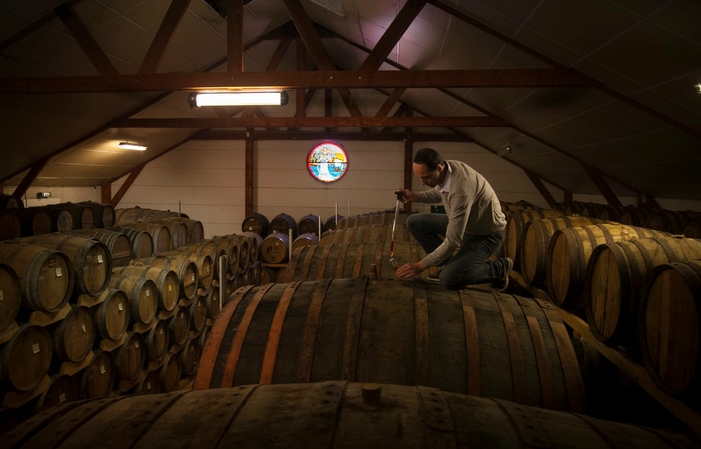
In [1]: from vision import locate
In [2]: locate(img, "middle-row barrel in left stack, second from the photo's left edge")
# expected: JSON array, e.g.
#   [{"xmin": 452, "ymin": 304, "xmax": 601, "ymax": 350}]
[{"xmin": 50, "ymin": 304, "xmax": 96, "ymax": 363}]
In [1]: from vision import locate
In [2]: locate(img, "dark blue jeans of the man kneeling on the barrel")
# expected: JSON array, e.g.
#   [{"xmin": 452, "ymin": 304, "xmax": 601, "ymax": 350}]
[{"xmin": 406, "ymin": 214, "xmax": 504, "ymax": 290}]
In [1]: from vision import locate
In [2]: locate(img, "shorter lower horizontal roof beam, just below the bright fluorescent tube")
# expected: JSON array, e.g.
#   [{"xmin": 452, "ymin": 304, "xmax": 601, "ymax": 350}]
[{"xmin": 111, "ymin": 116, "xmax": 508, "ymax": 128}]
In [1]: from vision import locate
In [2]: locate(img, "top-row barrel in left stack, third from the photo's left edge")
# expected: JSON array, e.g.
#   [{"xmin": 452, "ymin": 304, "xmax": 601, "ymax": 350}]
[{"xmin": 20, "ymin": 234, "xmax": 112, "ymax": 296}]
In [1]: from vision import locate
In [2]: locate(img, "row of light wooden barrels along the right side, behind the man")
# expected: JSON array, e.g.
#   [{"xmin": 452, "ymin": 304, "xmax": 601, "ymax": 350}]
[{"xmin": 504, "ymin": 206, "xmax": 701, "ymax": 399}]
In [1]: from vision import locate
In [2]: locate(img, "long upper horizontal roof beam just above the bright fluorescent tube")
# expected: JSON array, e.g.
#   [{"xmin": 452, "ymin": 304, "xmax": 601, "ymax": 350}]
[{"xmin": 0, "ymin": 68, "xmax": 597, "ymax": 92}]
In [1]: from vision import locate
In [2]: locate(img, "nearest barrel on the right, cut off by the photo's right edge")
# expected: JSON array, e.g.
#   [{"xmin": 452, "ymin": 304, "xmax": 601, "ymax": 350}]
[{"xmin": 638, "ymin": 259, "xmax": 701, "ymax": 399}]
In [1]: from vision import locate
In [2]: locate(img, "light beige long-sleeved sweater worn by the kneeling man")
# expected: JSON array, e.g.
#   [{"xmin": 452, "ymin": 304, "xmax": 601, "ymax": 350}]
[{"xmin": 418, "ymin": 161, "xmax": 506, "ymax": 267}]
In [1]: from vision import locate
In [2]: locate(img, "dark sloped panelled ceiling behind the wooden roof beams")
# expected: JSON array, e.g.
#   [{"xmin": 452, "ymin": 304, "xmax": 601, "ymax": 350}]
[{"xmin": 0, "ymin": 0, "xmax": 701, "ymax": 199}]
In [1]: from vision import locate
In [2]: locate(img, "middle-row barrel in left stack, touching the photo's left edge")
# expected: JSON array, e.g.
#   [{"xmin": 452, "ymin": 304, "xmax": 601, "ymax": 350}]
[{"xmin": 0, "ymin": 323, "xmax": 52, "ymax": 391}]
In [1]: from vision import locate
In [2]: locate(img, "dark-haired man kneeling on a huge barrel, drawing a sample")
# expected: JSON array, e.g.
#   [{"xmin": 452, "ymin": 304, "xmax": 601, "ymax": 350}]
[{"xmin": 396, "ymin": 148, "xmax": 513, "ymax": 291}]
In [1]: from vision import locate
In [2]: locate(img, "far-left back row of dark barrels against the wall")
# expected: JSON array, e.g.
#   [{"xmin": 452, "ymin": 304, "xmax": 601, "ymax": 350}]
[{"xmin": 0, "ymin": 201, "xmax": 115, "ymax": 240}]
